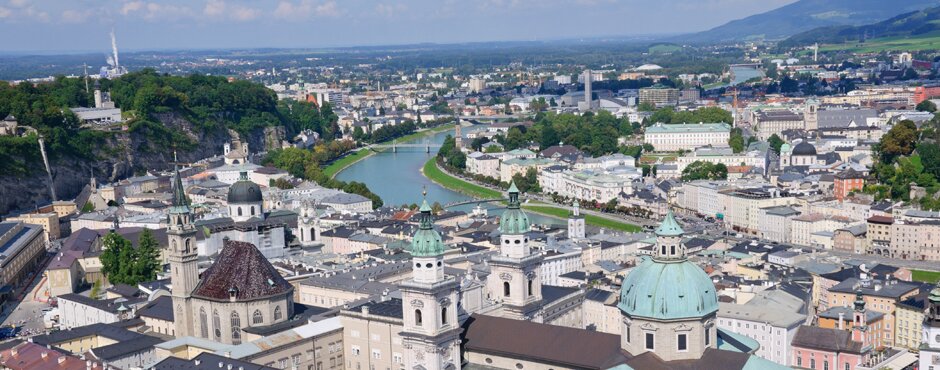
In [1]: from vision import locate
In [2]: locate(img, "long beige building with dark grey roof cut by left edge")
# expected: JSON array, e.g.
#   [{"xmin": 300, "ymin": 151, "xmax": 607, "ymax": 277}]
[{"xmin": 0, "ymin": 222, "xmax": 46, "ymax": 304}]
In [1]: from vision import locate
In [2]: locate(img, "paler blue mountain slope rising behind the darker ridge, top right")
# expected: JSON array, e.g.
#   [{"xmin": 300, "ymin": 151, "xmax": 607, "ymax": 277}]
[{"xmin": 672, "ymin": 0, "xmax": 940, "ymax": 42}]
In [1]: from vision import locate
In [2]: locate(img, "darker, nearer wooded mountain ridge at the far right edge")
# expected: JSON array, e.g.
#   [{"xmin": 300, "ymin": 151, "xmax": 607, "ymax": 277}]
[{"xmin": 780, "ymin": 7, "xmax": 940, "ymax": 46}]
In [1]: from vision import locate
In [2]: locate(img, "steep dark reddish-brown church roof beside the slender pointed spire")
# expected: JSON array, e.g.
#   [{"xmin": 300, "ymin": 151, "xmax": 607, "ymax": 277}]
[{"xmin": 193, "ymin": 240, "xmax": 294, "ymax": 301}]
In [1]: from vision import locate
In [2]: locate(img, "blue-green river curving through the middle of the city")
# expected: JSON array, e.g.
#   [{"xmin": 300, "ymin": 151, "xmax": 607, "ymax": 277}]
[{"xmin": 336, "ymin": 128, "xmax": 564, "ymax": 225}]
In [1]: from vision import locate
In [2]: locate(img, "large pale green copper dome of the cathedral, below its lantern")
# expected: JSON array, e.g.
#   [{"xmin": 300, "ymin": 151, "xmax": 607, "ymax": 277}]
[{"xmin": 617, "ymin": 258, "xmax": 718, "ymax": 320}]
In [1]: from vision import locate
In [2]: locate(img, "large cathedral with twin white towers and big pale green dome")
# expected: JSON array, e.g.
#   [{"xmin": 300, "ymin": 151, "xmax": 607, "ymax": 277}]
[{"xmin": 344, "ymin": 184, "xmax": 786, "ymax": 370}]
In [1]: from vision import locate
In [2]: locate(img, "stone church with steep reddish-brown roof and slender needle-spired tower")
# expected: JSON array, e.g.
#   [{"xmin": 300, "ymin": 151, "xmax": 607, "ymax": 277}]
[{"xmin": 167, "ymin": 171, "xmax": 294, "ymax": 344}]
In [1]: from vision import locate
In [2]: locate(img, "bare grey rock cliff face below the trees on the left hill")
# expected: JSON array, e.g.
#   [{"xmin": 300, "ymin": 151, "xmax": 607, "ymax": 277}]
[{"xmin": 0, "ymin": 113, "xmax": 286, "ymax": 215}]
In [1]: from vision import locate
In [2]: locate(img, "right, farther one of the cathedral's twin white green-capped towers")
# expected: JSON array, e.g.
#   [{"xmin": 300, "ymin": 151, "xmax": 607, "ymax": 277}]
[{"xmin": 486, "ymin": 182, "xmax": 542, "ymax": 322}]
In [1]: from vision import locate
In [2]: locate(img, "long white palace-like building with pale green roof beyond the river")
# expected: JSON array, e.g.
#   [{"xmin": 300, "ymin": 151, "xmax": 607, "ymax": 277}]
[{"xmin": 643, "ymin": 122, "xmax": 731, "ymax": 152}]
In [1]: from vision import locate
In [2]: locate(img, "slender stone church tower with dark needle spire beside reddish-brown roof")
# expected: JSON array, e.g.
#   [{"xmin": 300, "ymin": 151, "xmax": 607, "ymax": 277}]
[{"xmin": 166, "ymin": 169, "xmax": 199, "ymax": 337}]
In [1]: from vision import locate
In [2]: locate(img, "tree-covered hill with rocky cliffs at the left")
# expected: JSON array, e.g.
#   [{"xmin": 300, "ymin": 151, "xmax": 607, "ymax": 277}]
[{"xmin": 0, "ymin": 70, "xmax": 339, "ymax": 214}]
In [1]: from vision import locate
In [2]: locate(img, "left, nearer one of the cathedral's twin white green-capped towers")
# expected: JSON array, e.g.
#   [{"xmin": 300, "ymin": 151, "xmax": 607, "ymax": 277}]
[{"xmin": 400, "ymin": 195, "xmax": 461, "ymax": 370}]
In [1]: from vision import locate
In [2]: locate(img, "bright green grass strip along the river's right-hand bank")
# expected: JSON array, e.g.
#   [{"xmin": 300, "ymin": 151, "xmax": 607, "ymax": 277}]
[{"xmin": 421, "ymin": 157, "xmax": 642, "ymax": 233}]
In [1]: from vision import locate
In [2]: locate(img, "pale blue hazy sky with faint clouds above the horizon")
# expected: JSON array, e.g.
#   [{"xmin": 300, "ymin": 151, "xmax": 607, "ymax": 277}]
[{"xmin": 0, "ymin": 0, "xmax": 795, "ymax": 52}]
